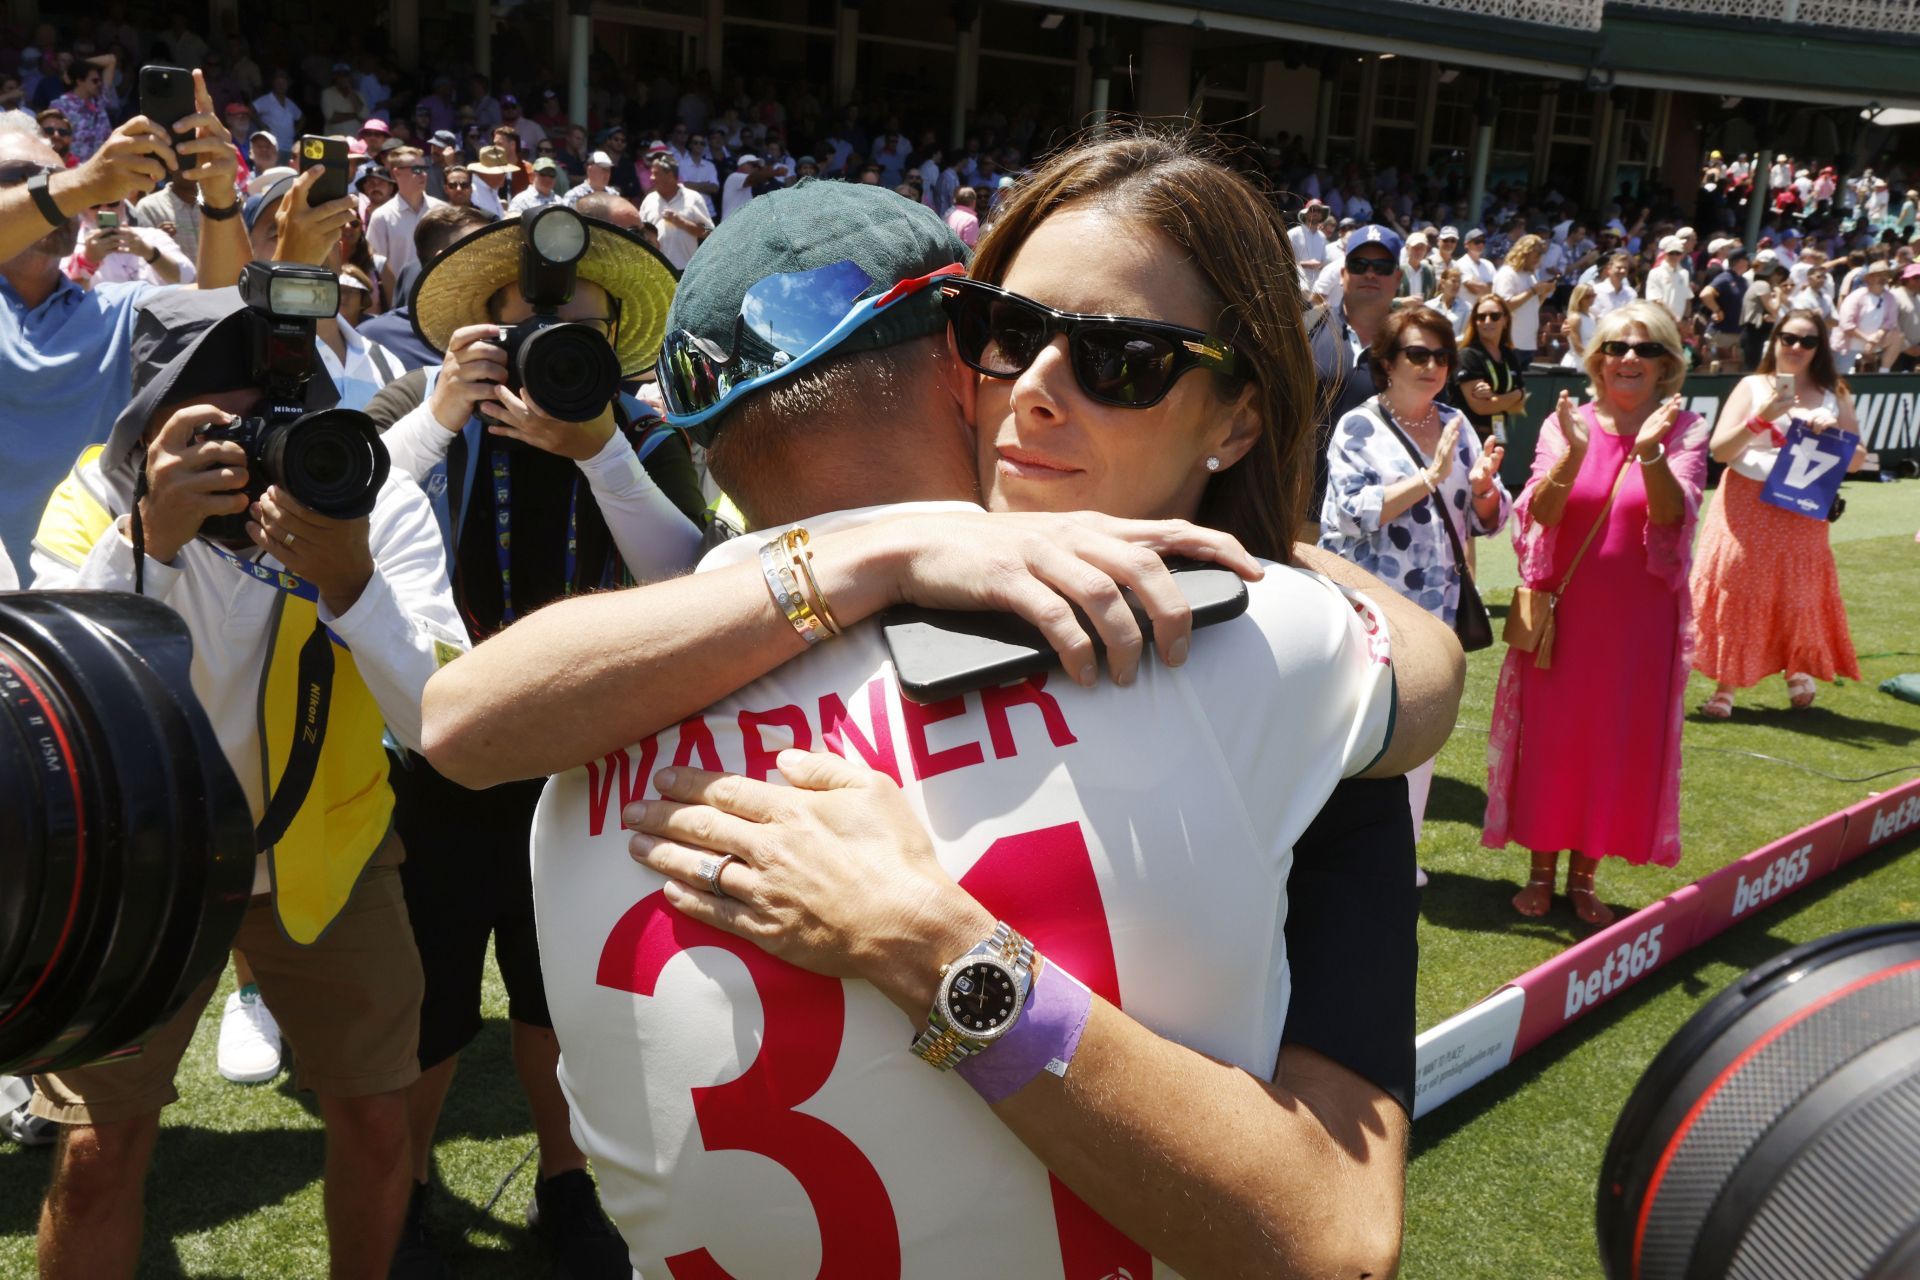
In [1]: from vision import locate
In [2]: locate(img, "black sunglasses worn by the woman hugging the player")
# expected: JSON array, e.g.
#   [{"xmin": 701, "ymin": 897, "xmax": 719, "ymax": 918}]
[{"xmin": 939, "ymin": 276, "xmax": 1235, "ymax": 409}]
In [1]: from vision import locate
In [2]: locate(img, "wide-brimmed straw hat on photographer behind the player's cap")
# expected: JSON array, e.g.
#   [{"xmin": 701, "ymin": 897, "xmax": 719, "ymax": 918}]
[{"xmin": 413, "ymin": 215, "xmax": 678, "ymax": 378}]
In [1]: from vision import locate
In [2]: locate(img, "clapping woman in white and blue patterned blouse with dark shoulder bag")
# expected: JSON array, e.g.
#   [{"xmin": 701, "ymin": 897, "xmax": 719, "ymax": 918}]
[{"xmin": 1321, "ymin": 310, "xmax": 1513, "ymax": 867}]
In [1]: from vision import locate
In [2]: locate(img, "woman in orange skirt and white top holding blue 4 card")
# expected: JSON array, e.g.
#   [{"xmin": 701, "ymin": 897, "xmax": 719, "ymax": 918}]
[{"xmin": 1693, "ymin": 311, "xmax": 1866, "ymax": 720}]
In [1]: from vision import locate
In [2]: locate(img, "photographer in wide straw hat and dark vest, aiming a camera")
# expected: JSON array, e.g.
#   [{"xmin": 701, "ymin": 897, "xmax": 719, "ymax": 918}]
[{"xmin": 369, "ymin": 209, "xmax": 701, "ymax": 1280}]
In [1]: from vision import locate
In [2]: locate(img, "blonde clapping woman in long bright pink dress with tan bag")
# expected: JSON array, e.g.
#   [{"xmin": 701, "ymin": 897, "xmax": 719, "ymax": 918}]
[{"xmin": 1480, "ymin": 303, "xmax": 1707, "ymax": 927}]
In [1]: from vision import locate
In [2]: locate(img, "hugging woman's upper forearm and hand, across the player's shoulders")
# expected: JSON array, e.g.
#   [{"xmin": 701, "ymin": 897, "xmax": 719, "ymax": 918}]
[{"xmin": 424, "ymin": 512, "xmax": 1261, "ymax": 787}]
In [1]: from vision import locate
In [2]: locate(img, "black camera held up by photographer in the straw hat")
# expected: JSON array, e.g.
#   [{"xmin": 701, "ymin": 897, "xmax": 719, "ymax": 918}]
[{"xmin": 482, "ymin": 205, "xmax": 620, "ymax": 422}]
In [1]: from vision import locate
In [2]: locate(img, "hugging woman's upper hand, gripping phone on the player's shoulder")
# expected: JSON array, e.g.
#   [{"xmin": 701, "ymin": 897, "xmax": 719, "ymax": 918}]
[{"xmin": 848, "ymin": 510, "xmax": 1263, "ymax": 687}]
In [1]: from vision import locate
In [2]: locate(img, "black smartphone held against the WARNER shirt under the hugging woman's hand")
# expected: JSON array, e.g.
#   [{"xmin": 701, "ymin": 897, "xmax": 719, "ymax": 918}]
[{"xmin": 879, "ymin": 560, "xmax": 1246, "ymax": 704}]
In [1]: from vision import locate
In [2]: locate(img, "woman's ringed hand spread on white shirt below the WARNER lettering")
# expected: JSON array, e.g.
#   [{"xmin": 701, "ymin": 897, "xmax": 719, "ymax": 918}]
[{"xmin": 622, "ymin": 750, "xmax": 995, "ymax": 1017}]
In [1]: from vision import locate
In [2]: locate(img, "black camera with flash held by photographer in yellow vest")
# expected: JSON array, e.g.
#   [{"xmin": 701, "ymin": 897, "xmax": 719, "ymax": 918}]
[{"xmin": 200, "ymin": 263, "xmax": 392, "ymax": 541}]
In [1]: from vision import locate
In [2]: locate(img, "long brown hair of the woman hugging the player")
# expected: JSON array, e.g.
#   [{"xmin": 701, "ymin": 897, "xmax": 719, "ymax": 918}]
[{"xmin": 972, "ymin": 127, "xmax": 1315, "ymax": 564}]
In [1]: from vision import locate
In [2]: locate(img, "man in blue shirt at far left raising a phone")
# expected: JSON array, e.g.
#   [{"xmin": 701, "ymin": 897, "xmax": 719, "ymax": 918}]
[{"xmin": 0, "ymin": 73, "xmax": 248, "ymax": 575}]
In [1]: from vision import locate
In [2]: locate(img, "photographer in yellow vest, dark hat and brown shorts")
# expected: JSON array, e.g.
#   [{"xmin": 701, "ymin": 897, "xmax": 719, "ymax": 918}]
[{"xmin": 33, "ymin": 267, "xmax": 467, "ymax": 1280}]
